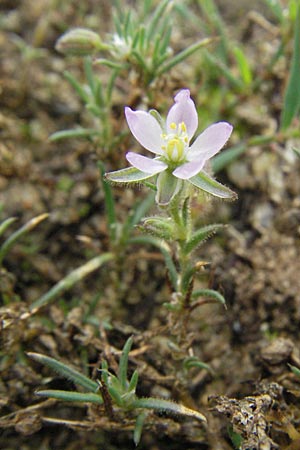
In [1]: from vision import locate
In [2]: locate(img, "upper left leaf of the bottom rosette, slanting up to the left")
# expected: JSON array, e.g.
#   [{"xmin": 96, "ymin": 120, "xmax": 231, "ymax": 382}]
[{"xmin": 27, "ymin": 352, "xmax": 99, "ymax": 392}]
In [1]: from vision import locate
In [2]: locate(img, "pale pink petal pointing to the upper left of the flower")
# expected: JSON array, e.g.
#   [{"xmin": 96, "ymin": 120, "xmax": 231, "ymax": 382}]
[{"xmin": 125, "ymin": 106, "xmax": 163, "ymax": 155}]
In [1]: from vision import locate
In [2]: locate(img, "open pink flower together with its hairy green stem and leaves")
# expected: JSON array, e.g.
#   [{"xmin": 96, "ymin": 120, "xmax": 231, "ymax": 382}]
[{"xmin": 106, "ymin": 89, "xmax": 236, "ymax": 338}]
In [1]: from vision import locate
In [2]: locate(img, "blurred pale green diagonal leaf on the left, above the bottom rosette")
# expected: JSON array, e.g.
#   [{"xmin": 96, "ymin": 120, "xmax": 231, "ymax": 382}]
[{"xmin": 30, "ymin": 253, "xmax": 114, "ymax": 312}]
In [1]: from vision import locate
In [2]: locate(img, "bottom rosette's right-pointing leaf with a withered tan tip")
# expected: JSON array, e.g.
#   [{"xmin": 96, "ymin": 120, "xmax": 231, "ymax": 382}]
[{"xmin": 133, "ymin": 397, "xmax": 207, "ymax": 422}]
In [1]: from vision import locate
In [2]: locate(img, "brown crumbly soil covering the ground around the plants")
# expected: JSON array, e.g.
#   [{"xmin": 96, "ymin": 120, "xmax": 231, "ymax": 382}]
[{"xmin": 0, "ymin": 0, "xmax": 300, "ymax": 450}]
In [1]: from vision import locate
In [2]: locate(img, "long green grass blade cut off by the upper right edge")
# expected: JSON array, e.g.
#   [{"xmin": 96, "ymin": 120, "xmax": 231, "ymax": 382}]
[{"xmin": 281, "ymin": 5, "xmax": 300, "ymax": 130}]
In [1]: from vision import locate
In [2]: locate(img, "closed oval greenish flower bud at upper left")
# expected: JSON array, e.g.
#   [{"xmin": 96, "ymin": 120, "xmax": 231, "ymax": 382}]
[{"xmin": 55, "ymin": 28, "xmax": 106, "ymax": 56}]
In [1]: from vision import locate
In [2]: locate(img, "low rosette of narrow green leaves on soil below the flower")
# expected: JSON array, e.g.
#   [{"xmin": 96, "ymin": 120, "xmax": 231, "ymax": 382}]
[{"xmin": 28, "ymin": 337, "xmax": 206, "ymax": 445}]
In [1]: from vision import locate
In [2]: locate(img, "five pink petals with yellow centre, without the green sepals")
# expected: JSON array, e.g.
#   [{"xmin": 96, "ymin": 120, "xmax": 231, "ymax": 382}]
[{"xmin": 125, "ymin": 89, "xmax": 233, "ymax": 180}]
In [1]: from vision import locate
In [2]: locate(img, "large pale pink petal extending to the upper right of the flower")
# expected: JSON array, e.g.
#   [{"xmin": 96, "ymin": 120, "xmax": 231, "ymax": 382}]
[{"xmin": 187, "ymin": 122, "xmax": 233, "ymax": 161}]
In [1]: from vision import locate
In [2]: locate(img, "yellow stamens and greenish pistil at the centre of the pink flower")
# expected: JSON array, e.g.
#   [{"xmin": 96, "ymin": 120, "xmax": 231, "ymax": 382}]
[{"xmin": 161, "ymin": 122, "xmax": 189, "ymax": 163}]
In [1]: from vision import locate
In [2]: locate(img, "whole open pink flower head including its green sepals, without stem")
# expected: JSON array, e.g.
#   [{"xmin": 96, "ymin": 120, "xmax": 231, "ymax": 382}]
[{"xmin": 107, "ymin": 89, "xmax": 235, "ymax": 204}]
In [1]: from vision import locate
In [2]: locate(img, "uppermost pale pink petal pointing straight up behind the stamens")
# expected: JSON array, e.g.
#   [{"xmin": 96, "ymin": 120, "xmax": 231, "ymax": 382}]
[{"xmin": 166, "ymin": 89, "xmax": 198, "ymax": 139}]
